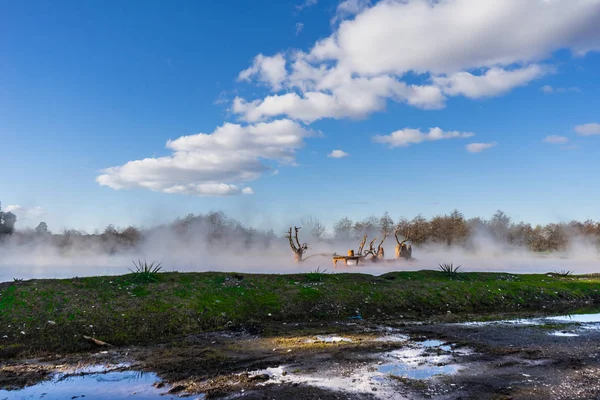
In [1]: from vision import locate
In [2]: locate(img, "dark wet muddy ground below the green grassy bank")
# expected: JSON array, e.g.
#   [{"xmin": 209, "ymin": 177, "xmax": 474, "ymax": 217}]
[{"xmin": 0, "ymin": 320, "xmax": 600, "ymax": 400}]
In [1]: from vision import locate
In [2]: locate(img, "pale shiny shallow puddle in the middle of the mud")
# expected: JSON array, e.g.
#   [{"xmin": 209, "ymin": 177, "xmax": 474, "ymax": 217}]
[{"xmin": 244, "ymin": 335, "xmax": 472, "ymax": 399}]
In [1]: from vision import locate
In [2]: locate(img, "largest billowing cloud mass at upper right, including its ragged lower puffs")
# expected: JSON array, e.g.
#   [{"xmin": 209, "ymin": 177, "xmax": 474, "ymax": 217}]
[{"xmin": 233, "ymin": 0, "xmax": 600, "ymax": 123}]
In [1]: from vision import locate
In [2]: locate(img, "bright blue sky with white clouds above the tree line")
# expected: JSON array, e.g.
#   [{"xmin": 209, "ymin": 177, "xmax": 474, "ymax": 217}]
[{"xmin": 0, "ymin": 0, "xmax": 600, "ymax": 231}]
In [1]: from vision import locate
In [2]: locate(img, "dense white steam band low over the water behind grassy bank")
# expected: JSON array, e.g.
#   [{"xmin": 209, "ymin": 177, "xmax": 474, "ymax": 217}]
[{"xmin": 0, "ymin": 239, "xmax": 600, "ymax": 282}]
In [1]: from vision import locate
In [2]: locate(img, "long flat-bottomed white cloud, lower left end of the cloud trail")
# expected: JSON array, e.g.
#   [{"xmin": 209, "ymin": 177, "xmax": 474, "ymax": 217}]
[{"xmin": 96, "ymin": 119, "xmax": 314, "ymax": 196}]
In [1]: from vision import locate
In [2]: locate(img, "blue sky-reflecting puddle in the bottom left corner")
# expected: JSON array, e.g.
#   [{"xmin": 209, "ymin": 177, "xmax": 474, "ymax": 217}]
[{"xmin": 0, "ymin": 367, "xmax": 183, "ymax": 400}]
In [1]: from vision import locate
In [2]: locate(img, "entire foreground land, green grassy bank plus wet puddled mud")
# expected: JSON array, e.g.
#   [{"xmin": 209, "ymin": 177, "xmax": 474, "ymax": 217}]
[{"xmin": 0, "ymin": 271, "xmax": 600, "ymax": 400}]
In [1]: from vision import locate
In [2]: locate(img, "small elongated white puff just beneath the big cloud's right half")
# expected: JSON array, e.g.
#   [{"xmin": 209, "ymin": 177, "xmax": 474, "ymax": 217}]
[{"xmin": 433, "ymin": 65, "xmax": 551, "ymax": 99}]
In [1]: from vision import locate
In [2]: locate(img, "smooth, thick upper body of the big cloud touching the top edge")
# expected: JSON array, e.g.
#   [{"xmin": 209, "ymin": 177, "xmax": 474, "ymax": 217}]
[{"xmin": 311, "ymin": 0, "xmax": 600, "ymax": 76}]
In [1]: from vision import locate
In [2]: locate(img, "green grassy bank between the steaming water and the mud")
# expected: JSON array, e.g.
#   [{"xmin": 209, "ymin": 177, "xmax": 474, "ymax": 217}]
[{"xmin": 0, "ymin": 271, "xmax": 600, "ymax": 357}]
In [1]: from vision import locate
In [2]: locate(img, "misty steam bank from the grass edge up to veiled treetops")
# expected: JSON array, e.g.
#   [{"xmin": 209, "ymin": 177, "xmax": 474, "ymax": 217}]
[{"xmin": 0, "ymin": 212, "xmax": 600, "ymax": 282}]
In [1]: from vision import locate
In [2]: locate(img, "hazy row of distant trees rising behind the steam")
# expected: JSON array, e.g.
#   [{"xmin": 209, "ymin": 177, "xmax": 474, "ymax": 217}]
[{"xmin": 0, "ymin": 205, "xmax": 600, "ymax": 253}]
